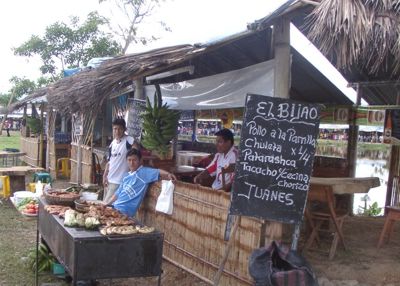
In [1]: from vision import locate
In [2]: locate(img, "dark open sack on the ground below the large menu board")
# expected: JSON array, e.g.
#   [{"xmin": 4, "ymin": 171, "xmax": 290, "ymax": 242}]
[{"xmin": 249, "ymin": 241, "xmax": 318, "ymax": 286}]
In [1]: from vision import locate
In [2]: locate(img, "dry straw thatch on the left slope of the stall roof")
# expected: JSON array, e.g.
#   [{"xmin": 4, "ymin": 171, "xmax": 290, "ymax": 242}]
[{"xmin": 33, "ymin": 45, "xmax": 204, "ymax": 113}]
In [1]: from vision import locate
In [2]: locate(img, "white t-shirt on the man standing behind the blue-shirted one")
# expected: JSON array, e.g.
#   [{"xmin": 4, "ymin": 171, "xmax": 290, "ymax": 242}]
[{"xmin": 107, "ymin": 135, "xmax": 133, "ymax": 184}]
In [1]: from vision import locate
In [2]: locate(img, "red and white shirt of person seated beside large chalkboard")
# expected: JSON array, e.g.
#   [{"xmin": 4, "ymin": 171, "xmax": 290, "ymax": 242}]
[{"xmin": 206, "ymin": 146, "xmax": 238, "ymax": 190}]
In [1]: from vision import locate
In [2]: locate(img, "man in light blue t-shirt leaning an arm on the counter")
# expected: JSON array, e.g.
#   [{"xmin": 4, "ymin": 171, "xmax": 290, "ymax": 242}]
[{"xmin": 106, "ymin": 149, "xmax": 176, "ymax": 217}]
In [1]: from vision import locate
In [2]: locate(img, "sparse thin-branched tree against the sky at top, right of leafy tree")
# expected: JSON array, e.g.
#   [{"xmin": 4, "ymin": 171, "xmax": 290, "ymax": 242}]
[{"xmin": 99, "ymin": 0, "xmax": 171, "ymax": 55}]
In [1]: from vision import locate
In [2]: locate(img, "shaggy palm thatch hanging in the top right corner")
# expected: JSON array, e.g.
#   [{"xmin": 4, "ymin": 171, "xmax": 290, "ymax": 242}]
[{"xmin": 305, "ymin": 0, "xmax": 400, "ymax": 75}]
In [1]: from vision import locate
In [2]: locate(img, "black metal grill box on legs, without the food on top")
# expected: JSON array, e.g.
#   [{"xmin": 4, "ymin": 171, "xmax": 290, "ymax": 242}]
[{"xmin": 36, "ymin": 198, "xmax": 164, "ymax": 285}]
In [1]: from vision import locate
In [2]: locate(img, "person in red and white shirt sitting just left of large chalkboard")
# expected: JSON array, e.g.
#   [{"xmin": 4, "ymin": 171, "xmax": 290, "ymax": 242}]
[{"xmin": 194, "ymin": 129, "xmax": 238, "ymax": 191}]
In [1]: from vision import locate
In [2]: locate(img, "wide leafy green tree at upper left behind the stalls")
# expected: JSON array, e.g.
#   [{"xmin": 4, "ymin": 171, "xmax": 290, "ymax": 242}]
[{"xmin": 14, "ymin": 12, "xmax": 121, "ymax": 81}]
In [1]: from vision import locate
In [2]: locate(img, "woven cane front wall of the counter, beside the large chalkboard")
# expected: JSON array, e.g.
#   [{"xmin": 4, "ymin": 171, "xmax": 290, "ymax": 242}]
[{"xmin": 139, "ymin": 182, "xmax": 261, "ymax": 285}]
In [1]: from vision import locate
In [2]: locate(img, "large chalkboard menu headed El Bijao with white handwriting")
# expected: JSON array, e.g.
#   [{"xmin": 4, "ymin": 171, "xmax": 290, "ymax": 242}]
[{"xmin": 230, "ymin": 94, "xmax": 320, "ymax": 223}]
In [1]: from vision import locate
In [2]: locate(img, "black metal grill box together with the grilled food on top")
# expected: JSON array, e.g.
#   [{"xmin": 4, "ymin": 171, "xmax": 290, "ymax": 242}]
[{"xmin": 37, "ymin": 190, "xmax": 164, "ymax": 285}]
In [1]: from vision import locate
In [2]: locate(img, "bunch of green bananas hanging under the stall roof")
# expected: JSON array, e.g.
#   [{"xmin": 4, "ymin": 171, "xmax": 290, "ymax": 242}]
[{"xmin": 140, "ymin": 85, "xmax": 180, "ymax": 158}]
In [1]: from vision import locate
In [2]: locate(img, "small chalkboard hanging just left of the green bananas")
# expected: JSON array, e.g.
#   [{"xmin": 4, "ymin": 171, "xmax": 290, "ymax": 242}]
[{"xmin": 126, "ymin": 98, "xmax": 146, "ymax": 141}]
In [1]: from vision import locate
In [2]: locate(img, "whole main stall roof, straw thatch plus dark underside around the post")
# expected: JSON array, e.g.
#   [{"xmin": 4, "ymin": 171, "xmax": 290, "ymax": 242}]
[{"xmin": 10, "ymin": 0, "xmax": 362, "ymax": 113}]
